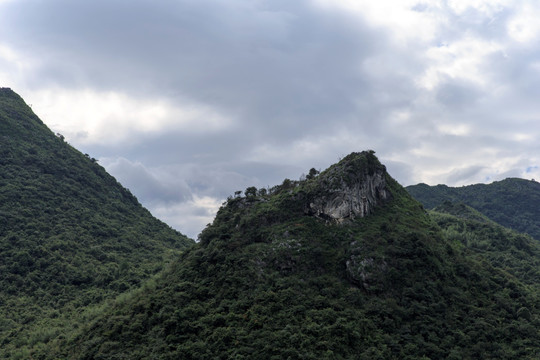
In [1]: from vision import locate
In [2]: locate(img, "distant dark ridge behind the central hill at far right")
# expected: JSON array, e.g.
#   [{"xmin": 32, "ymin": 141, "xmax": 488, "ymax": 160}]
[{"xmin": 406, "ymin": 178, "xmax": 540, "ymax": 240}]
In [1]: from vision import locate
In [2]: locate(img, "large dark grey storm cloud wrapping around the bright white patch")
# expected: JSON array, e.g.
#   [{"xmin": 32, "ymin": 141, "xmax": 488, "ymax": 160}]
[{"xmin": 0, "ymin": 0, "xmax": 422, "ymax": 179}]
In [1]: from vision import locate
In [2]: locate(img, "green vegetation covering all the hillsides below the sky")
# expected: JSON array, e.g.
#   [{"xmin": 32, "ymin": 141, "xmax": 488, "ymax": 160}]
[{"xmin": 0, "ymin": 89, "xmax": 540, "ymax": 360}]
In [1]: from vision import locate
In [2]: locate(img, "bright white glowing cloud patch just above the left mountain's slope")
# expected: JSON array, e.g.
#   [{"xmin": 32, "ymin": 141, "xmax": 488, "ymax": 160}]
[{"xmin": 27, "ymin": 88, "xmax": 232, "ymax": 146}]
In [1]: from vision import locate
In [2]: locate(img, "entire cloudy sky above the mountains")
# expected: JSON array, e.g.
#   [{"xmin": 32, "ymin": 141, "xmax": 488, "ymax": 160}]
[{"xmin": 0, "ymin": 0, "xmax": 540, "ymax": 238}]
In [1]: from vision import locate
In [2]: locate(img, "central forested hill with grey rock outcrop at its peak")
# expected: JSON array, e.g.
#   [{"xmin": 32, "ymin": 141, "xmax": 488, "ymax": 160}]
[{"xmin": 57, "ymin": 151, "xmax": 540, "ymax": 359}]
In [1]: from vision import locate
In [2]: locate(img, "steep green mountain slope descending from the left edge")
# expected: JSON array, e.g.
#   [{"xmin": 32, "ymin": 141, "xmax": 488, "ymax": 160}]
[{"xmin": 0, "ymin": 88, "xmax": 193, "ymax": 359}]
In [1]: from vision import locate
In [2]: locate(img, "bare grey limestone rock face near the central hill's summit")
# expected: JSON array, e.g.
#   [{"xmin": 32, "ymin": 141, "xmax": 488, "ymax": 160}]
[{"xmin": 305, "ymin": 151, "xmax": 391, "ymax": 223}]
